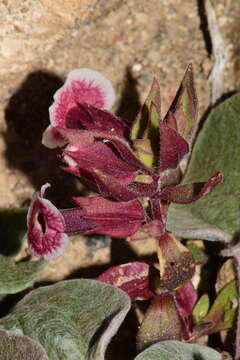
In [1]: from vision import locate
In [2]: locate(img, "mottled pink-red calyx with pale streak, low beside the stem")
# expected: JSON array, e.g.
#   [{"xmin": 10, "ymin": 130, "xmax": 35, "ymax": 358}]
[{"xmin": 97, "ymin": 261, "xmax": 155, "ymax": 301}]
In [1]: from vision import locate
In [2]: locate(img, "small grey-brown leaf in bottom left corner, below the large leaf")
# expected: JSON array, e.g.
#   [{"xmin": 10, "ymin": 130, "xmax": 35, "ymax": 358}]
[{"xmin": 0, "ymin": 330, "xmax": 49, "ymax": 360}]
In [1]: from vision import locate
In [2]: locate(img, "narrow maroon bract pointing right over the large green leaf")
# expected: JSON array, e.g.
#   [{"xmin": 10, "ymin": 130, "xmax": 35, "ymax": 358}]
[{"xmin": 159, "ymin": 172, "xmax": 223, "ymax": 204}]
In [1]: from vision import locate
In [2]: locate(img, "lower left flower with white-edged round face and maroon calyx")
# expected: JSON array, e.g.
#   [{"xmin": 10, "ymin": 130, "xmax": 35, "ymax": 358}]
[{"xmin": 28, "ymin": 184, "xmax": 145, "ymax": 260}]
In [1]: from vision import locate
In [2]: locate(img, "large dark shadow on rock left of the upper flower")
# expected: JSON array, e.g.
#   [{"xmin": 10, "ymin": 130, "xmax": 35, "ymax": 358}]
[{"xmin": 3, "ymin": 71, "xmax": 80, "ymax": 206}]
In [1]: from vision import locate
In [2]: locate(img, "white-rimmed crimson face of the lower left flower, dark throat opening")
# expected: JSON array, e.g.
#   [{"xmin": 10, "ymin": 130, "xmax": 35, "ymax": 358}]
[{"xmin": 27, "ymin": 184, "xmax": 68, "ymax": 260}]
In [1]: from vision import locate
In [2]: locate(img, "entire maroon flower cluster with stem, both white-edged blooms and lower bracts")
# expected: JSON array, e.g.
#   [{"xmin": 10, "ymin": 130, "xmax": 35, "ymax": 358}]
[{"xmin": 28, "ymin": 65, "xmax": 222, "ymax": 342}]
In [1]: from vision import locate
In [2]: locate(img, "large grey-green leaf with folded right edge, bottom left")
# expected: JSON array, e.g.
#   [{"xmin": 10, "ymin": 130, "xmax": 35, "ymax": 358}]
[{"xmin": 0, "ymin": 279, "xmax": 131, "ymax": 360}]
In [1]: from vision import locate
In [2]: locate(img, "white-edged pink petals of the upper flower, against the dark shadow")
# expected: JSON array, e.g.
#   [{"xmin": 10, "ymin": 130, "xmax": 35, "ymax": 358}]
[{"xmin": 42, "ymin": 69, "xmax": 115, "ymax": 148}]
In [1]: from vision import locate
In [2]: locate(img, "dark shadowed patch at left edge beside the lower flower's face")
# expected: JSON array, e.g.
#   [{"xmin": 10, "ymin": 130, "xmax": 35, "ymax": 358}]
[{"xmin": 0, "ymin": 208, "xmax": 27, "ymax": 256}]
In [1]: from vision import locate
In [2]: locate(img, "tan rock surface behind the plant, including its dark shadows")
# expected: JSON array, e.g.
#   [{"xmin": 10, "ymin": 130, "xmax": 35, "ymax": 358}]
[{"xmin": 0, "ymin": 0, "xmax": 240, "ymax": 281}]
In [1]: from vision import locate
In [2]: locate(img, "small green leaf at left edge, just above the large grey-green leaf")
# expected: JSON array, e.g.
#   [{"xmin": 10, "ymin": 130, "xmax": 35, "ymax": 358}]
[{"xmin": 0, "ymin": 255, "xmax": 46, "ymax": 294}]
